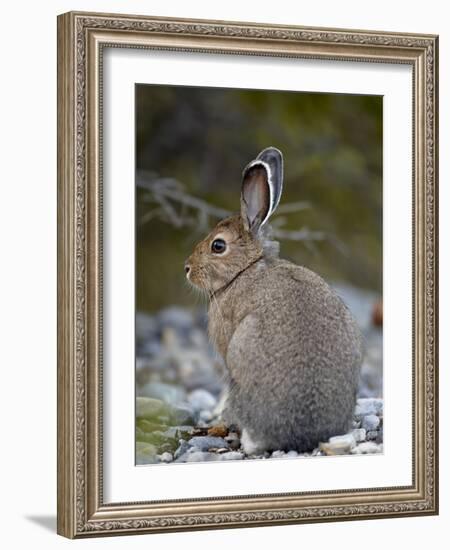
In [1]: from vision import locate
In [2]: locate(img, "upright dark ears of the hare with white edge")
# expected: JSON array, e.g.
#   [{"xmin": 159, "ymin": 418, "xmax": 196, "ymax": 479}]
[{"xmin": 241, "ymin": 147, "xmax": 283, "ymax": 233}]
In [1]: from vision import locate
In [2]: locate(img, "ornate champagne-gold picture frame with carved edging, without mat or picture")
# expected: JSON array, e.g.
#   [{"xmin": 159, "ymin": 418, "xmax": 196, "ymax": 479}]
[{"xmin": 58, "ymin": 13, "xmax": 438, "ymax": 538}]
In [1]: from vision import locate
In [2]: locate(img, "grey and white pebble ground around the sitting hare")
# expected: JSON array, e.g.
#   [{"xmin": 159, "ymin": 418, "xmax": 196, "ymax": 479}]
[{"xmin": 136, "ymin": 286, "xmax": 383, "ymax": 464}]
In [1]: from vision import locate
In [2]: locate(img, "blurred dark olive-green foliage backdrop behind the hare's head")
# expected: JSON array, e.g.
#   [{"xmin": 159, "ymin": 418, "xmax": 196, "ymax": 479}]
[{"xmin": 136, "ymin": 84, "xmax": 382, "ymax": 312}]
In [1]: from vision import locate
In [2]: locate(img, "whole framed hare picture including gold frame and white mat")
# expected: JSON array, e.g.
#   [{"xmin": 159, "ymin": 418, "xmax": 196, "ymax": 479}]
[{"xmin": 58, "ymin": 12, "xmax": 438, "ymax": 538}]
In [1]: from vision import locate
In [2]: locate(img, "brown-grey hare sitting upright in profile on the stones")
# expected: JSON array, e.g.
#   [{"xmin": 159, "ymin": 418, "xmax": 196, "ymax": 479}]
[{"xmin": 185, "ymin": 147, "xmax": 363, "ymax": 455}]
